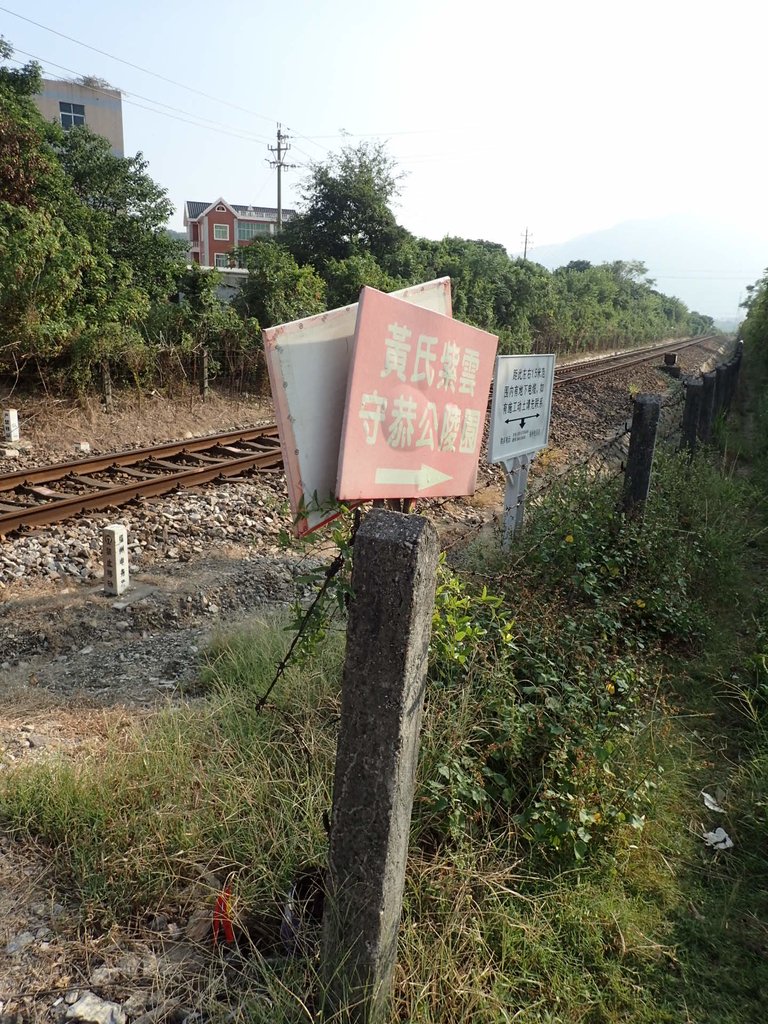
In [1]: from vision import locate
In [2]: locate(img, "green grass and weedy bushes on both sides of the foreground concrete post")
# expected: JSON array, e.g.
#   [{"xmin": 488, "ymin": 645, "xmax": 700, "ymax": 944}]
[{"xmin": 0, "ymin": 374, "xmax": 768, "ymax": 1024}]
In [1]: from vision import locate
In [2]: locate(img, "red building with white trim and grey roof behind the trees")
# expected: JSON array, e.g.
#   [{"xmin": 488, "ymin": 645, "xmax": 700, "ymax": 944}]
[{"xmin": 184, "ymin": 199, "xmax": 294, "ymax": 268}]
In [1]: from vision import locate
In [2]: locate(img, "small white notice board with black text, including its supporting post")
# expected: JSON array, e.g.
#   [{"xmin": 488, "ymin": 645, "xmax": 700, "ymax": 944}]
[{"xmin": 488, "ymin": 355, "xmax": 555, "ymax": 547}]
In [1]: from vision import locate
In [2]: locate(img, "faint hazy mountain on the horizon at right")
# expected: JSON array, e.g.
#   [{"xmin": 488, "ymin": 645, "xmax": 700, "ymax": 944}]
[{"xmin": 528, "ymin": 215, "xmax": 768, "ymax": 319}]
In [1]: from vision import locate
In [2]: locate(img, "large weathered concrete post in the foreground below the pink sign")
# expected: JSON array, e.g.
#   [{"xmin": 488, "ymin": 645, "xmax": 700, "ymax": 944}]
[{"xmin": 322, "ymin": 509, "xmax": 439, "ymax": 1024}]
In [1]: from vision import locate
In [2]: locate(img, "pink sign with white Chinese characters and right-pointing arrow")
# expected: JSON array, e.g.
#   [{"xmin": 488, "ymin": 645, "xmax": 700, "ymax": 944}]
[{"xmin": 336, "ymin": 288, "xmax": 499, "ymax": 501}]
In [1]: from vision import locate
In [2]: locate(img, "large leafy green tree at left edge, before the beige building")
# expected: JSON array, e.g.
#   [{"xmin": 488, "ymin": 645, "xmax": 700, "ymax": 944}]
[{"xmin": 0, "ymin": 42, "xmax": 183, "ymax": 383}]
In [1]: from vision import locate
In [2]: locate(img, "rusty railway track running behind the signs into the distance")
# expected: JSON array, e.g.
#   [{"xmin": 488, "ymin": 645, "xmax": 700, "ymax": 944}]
[{"xmin": 0, "ymin": 337, "xmax": 720, "ymax": 539}]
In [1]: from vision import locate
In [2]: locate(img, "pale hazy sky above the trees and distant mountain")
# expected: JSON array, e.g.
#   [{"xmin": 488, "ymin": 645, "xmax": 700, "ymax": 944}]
[{"xmin": 0, "ymin": 0, "xmax": 768, "ymax": 274}]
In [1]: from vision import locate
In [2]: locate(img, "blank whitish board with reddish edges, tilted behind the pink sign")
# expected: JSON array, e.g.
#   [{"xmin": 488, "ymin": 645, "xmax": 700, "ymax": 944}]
[{"xmin": 263, "ymin": 278, "xmax": 452, "ymax": 536}]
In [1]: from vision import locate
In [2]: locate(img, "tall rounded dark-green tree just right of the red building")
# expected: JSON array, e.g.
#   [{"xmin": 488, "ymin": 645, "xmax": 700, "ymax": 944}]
[{"xmin": 283, "ymin": 142, "xmax": 408, "ymax": 272}]
